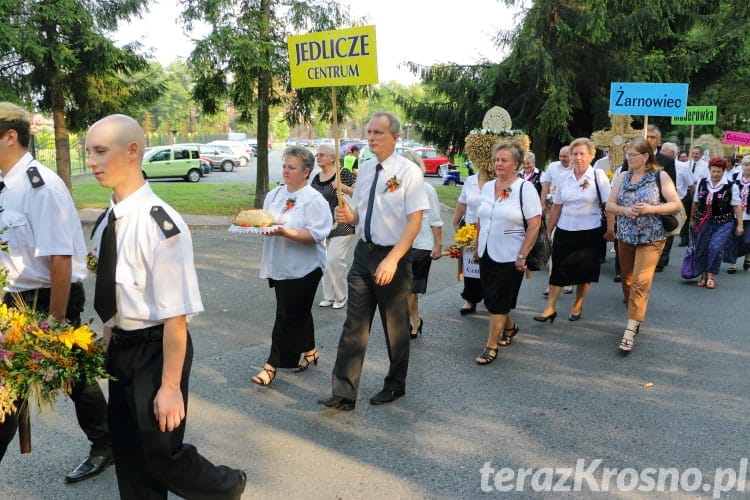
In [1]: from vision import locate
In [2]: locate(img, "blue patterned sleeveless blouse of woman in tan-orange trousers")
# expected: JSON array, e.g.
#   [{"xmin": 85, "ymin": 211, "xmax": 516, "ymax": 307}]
[{"xmin": 617, "ymin": 171, "xmax": 667, "ymax": 245}]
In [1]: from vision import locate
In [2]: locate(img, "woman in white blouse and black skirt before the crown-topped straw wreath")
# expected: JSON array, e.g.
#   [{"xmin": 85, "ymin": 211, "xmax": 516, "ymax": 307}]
[{"xmin": 476, "ymin": 141, "xmax": 542, "ymax": 365}]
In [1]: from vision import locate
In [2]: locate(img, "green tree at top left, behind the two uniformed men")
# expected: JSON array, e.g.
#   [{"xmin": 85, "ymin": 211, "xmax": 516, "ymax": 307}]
[{"xmin": 0, "ymin": 0, "xmax": 159, "ymax": 188}]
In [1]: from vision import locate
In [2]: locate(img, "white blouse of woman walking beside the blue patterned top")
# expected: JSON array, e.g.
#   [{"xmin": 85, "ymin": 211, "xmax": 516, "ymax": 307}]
[{"xmin": 553, "ymin": 166, "xmax": 611, "ymax": 231}]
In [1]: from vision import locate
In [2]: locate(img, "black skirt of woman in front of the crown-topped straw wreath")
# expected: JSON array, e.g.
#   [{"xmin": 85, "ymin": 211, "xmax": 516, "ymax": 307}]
[{"xmin": 479, "ymin": 250, "xmax": 523, "ymax": 314}]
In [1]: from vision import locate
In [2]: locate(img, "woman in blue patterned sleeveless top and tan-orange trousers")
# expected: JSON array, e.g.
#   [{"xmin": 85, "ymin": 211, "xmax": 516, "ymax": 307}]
[{"xmin": 606, "ymin": 138, "xmax": 682, "ymax": 355}]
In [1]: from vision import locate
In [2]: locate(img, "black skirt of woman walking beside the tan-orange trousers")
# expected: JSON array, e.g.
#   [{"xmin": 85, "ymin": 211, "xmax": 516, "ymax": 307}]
[{"xmin": 549, "ymin": 227, "xmax": 606, "ymax": 286}]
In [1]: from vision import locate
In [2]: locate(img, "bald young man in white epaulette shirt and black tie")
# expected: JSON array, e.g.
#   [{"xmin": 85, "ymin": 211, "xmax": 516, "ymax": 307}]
[{"xmin": 86, "ymin": 115, "xmax": 247, "ymax": 500}]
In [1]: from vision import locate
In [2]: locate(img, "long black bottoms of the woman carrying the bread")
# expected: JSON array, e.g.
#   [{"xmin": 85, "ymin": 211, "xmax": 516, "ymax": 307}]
[{"xmin": 266, "ymin": 267, "xmax": 323, "ymax": 368}]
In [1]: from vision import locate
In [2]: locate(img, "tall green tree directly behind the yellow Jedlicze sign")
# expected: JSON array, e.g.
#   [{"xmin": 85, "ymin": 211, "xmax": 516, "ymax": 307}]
[{"xmin": 183, "ymin": 0, "xmax": 356, "ymax": 207}]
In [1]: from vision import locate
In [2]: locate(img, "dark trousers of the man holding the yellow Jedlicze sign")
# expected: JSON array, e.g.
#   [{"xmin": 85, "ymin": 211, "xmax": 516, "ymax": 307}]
[{"xmin": 333, "ymin": 241, "xmax": 412, "ymax": 400}]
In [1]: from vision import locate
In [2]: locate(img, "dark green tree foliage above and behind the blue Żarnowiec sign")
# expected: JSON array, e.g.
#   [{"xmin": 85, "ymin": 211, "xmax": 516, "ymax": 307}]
[{"xmin": 409, "ymin": 0, "xmax": 750, "ymax": 162}]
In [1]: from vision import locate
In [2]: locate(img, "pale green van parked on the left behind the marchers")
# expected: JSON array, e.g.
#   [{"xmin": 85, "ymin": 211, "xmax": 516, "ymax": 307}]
[{"xmin": 141, "ymin": 144, "xmax": 204, "ymax": 182}]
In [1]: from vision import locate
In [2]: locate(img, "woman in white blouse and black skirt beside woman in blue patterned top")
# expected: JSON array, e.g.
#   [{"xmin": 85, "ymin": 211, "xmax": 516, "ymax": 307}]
[{"xmin": 534, "ymin": 138, "xmax": 614, "ymax": 323}]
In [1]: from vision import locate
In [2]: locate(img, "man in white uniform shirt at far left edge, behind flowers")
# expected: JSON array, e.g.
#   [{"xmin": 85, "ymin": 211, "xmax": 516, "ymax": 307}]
[{"xmin": 0, "ymin": 102, "xmax": 112, "ymax": 483}]
